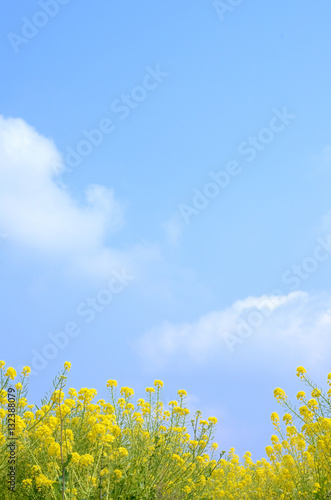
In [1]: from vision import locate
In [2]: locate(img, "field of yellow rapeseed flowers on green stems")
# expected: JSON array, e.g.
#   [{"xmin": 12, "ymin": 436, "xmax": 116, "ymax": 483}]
[{"xmin": 0, "ymin": 361, "xmax": 331, "ymax": 500}]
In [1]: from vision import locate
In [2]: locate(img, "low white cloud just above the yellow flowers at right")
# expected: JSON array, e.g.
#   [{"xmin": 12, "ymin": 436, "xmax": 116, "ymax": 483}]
[{"xmin": 137, "ymin": 292, "xmax": 331, "ymax": 366}]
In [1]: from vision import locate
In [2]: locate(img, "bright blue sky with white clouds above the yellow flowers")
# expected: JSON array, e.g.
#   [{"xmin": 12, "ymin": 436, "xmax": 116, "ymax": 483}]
[{"xmin": 0, "ymin": 0, "xmax": 331, "ymax": 459}]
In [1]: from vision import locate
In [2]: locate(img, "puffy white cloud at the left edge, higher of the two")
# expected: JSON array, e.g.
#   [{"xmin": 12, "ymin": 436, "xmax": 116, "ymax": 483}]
[{"xmin": 0, "ymin": 116, "xmax": 155, "ymax": 275}]
